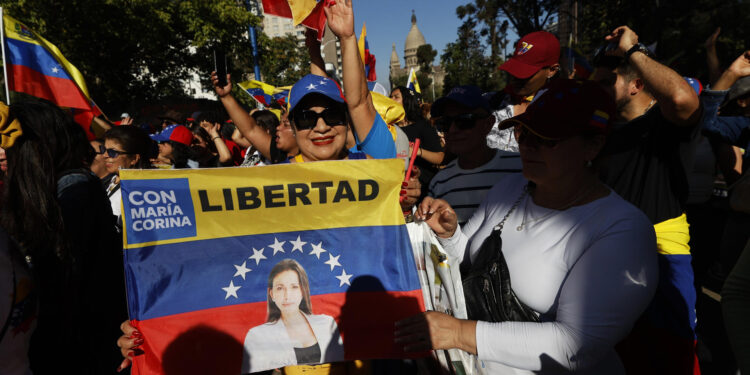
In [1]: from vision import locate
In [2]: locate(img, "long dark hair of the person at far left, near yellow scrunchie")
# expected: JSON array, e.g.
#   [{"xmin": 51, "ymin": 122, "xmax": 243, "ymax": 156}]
[{"xmin": 0, "ymin": 101, "xmax": 94, "ymax": 260}]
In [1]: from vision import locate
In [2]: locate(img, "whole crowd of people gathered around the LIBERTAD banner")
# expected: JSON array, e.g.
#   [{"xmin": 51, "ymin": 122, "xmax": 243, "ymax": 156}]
[{"xmin": 0, "ymin": 1, "xmax": 750, "ymax": 374}]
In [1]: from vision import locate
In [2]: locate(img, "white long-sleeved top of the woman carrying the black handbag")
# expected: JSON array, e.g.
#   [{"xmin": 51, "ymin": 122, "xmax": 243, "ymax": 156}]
[{"xmin": 441, "ymin": 175, "xmax": 658, "ymax": 374}]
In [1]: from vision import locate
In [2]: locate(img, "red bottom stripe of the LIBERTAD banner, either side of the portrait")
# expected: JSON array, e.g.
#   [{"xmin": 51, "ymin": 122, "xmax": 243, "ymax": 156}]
[{"xmin": 131, "ymin": 290, "xmax": 425, "ymax": 375}]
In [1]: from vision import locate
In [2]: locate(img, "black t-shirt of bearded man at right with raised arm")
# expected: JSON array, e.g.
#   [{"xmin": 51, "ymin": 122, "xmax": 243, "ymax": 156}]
[{"xmin": 598, "ymin": 105, "xmax": 698, "ymax": 224}]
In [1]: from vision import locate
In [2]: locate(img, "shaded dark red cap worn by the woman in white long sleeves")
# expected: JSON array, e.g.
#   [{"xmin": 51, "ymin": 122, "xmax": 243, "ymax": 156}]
[{"xmin": 499, "ymin": 79, "xmax": 616, "ymax": 140}]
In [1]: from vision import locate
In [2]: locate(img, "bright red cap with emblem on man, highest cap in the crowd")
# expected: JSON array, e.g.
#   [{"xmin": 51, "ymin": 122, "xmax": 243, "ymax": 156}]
[{"xmin": 500, "ymin": 31, "xmax": 560, "ymax": 79}]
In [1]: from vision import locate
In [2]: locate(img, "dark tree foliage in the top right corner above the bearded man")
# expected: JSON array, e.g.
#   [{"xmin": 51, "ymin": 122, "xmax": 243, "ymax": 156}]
[{"xmin": 577, "ymin": 0, "xmax": 750, "ymax": 82}]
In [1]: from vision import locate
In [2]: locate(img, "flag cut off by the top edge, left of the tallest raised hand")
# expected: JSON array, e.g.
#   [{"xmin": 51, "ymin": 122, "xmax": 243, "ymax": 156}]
[{"xmin": 263, "ymin": 0, "xmax": 331, "ymax": 40}]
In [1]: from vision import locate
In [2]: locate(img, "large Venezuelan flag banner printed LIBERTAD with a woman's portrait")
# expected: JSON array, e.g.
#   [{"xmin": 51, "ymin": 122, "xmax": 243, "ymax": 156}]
[{"xmin": 121, "ymin": 159, "xmax": 424, "ymax": 374}]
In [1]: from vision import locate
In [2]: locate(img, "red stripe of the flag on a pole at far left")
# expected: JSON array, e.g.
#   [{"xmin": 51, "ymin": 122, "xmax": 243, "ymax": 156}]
[{"xmin": 8, "ymin": 64, "xmax": 91, "ymax": 109}]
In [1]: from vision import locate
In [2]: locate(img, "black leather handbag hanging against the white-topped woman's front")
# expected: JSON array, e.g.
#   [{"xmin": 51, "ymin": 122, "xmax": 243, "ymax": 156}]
[{"xmin": 462, "ymin": 189, "xmax": 539, "ymax": 322}]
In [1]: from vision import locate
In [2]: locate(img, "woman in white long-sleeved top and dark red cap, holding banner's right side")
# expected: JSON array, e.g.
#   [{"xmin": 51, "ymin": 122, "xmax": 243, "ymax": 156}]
[{"xmin": 396, "ymin": 80, "xmax": 658, "ymax": 374}]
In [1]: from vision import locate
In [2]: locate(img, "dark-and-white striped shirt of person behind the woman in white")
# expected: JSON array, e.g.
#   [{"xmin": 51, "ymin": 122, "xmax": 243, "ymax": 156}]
[{"xmin": 429, "ymin": 150, "xmax": 521, "ymax": 224}]
